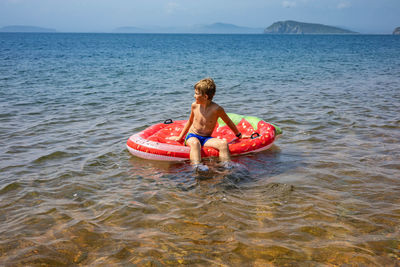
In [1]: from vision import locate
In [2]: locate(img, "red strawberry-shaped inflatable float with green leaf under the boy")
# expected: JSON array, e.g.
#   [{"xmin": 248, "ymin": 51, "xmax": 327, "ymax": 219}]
[{"xmin": 126, "ymin": 113, "xmax": 282, "ymax": 161}]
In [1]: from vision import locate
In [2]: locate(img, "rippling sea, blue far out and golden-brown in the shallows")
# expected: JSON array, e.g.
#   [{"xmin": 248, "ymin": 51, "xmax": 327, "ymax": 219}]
[{"xmin": 0, "ymin": 33, "xmax": 400, "ymax": 266}]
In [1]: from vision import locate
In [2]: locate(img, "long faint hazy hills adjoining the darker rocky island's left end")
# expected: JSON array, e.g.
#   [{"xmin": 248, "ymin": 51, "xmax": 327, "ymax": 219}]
[{"xmin": 113, "ymin": 23, "xmax": 263, "ymax": 34}]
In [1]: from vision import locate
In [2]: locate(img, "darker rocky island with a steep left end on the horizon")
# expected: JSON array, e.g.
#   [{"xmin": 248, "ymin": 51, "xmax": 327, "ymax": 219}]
[{"xmin": 264, "ymin": 20, "xmax": 356, "ymax": 34}]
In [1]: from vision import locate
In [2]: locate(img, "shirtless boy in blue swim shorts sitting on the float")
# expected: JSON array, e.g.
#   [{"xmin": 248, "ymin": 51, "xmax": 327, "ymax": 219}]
[{"xmin": 170, "ymin": 78, "xmax": 242, "ymax": 170}]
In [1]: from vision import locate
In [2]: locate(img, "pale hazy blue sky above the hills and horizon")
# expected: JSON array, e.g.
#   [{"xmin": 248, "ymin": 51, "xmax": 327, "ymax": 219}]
[{"xmin": 0, "ymin": 0, "xmax": 400, "ymax": 34}]
